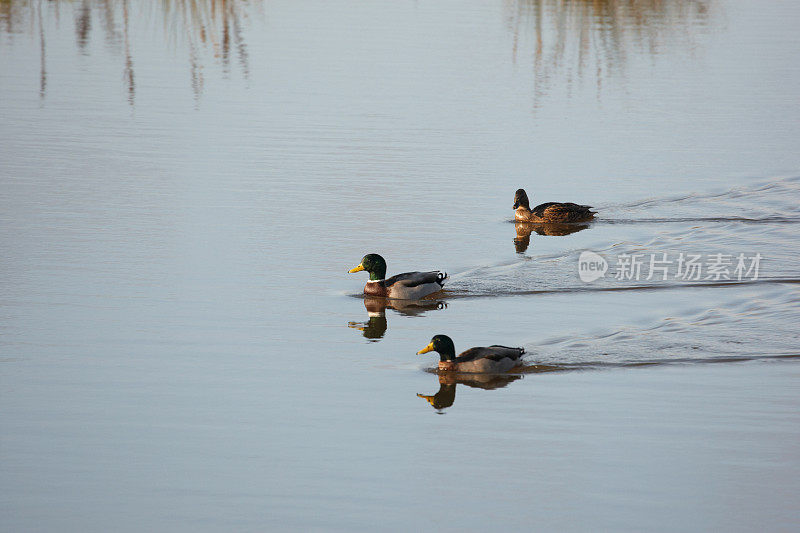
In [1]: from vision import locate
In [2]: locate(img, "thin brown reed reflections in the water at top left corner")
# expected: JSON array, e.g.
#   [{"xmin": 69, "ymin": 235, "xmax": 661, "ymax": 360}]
[{"xmin": 0, "ymin": 0, "xmax": 253, "ymax": 105}]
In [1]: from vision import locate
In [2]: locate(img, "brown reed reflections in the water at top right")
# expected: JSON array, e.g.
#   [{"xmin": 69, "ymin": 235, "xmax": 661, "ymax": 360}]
[{"xmin": 507, "ymin": 0, "xmax": 712, "ymax": 106}]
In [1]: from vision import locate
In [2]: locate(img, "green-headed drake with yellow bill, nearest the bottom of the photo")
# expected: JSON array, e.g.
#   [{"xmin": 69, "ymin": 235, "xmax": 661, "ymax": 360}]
[{"xmin": 417, "ymin": 335, "xmax": 525, "ymax": 374}]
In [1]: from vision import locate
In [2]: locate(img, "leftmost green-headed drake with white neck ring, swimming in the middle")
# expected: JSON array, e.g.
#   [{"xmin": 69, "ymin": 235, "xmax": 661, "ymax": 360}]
[{"xmin": 348, "ymin": 254, "xmax": 447, "ymax": 300}]
